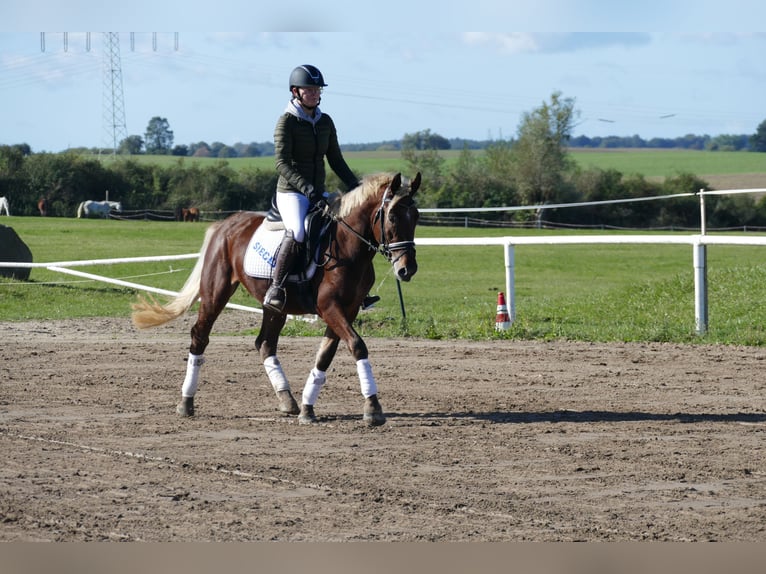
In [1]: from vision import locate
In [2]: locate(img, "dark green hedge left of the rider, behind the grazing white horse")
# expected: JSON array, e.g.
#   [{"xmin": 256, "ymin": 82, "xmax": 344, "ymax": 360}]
[{"xmin": 0, "ymin": 146, "xmax": 277, "ymax": 217}]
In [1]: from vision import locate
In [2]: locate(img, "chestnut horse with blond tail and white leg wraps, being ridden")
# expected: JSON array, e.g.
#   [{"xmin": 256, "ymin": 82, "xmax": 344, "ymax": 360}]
[{"xmin": 133, "ymin": 173, "xmax": 420, "ymax": 426}]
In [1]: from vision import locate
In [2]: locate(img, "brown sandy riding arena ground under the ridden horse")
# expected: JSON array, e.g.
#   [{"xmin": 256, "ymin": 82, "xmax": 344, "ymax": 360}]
[{"xmin": 0, "ymin": 312, "xmax": 766, "ymax": 542}]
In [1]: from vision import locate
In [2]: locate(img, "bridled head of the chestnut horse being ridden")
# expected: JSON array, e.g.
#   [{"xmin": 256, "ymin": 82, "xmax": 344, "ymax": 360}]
[{"xmin": 372, "ymin": 172, "xmax": 420, "ymax": 281}]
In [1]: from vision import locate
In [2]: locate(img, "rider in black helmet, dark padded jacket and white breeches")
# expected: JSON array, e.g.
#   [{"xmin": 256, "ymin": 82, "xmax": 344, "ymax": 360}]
[{"xmin": 263, "ymin": 64, "xmax": 380, "ymax": 313}]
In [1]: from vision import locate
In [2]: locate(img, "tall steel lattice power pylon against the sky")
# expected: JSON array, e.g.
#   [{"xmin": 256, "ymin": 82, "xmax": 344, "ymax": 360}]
[{"xmin": 103, "ymin": 32, "xmax": 128, "ymax": 155}]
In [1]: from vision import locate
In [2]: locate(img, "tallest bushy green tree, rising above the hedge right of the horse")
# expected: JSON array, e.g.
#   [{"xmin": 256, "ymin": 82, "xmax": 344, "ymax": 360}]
[{"xmin": 513, "ymin": 92, "xmax": 579, "ymax": 205}]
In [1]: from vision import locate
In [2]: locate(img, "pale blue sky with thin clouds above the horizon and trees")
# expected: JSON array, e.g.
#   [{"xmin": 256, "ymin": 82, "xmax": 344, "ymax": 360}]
[{"xmin": 0, "ymin": 0, "xmax": 766, "ymax": 151}]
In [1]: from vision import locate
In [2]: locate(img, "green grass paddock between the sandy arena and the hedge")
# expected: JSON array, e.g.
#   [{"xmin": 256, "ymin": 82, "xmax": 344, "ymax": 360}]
[{"xmin": 0, "ymin": 217, "xmax": 766, "ymax": 346}]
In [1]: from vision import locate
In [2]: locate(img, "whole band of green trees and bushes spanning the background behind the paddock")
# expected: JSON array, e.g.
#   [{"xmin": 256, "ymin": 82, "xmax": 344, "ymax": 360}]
[{"xmin": 0, "ymin": 92, "xmax": 766, "ymax": 228}]
